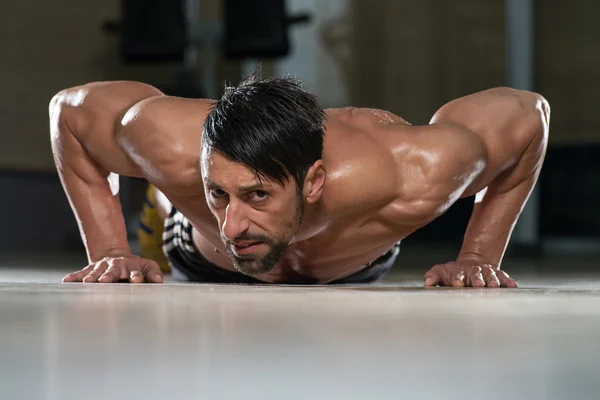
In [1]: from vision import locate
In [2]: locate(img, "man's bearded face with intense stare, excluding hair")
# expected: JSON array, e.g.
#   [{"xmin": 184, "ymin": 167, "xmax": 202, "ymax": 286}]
[{"xmin": 201, "ymin": 146, "xmax": 304, "ymax": 275}]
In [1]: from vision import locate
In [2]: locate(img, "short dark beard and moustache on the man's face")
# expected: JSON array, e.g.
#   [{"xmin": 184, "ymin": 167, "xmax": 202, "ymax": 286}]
[{"xmin": 222, "ymin": 196, "xmax": 304, "ymax": 276}]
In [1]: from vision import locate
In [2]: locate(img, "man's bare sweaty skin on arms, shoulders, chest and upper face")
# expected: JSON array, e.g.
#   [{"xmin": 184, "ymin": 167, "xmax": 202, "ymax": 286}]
[{"xmin": 50, "ymin": 82, "xmax": 550, "ymax": 287}]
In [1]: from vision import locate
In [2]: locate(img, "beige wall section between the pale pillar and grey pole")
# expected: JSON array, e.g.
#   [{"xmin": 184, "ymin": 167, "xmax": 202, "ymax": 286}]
[{"xmin": 351, "ymin": 0, "xmax": 505, "ymax": 123}]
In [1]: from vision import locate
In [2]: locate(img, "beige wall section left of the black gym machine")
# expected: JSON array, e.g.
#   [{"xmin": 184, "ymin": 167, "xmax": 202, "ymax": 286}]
[{"xmin": 0, "ymin": 0, "xmax": 240, "ymax": 171}]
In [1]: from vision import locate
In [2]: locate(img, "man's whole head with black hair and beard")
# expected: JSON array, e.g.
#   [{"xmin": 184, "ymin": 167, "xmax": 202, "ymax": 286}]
[{"xmin": 201, "ymin": 75, "xmax": 325, "ymax": 275}]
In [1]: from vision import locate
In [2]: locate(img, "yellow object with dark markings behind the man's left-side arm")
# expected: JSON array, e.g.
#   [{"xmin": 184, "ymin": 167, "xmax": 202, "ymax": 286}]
[{"xmin": 137, "ymin": 185, "xmax": 171, "ymax": 273}]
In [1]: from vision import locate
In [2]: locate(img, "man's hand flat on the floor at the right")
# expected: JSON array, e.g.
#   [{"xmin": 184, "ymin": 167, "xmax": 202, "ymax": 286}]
[{"xmin": 424, "ymin": 260, "xmax": 518, "ymax": 288}]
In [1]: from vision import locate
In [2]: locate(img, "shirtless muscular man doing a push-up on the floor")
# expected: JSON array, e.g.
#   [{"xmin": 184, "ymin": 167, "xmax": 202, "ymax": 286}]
[{"xmin": 50, "ymin": 76, "xmax": 550, "ymax": 287}]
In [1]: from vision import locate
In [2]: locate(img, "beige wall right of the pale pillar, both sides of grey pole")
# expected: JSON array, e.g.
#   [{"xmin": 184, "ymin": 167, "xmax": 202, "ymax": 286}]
[{"xmin": 349, "ymin": 0, "xmax": 600, "ymax": 146}]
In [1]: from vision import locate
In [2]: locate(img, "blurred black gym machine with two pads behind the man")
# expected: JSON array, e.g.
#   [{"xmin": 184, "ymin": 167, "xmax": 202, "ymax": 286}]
[{"xmin": 103, "ymin": 0, "xmax": 311, "ymax": 98}]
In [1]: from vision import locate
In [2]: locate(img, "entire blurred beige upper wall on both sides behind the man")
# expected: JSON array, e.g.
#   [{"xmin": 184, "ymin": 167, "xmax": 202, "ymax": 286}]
[{"xmin": 0, "ymin": 0, "xmax": 600, "ymax": 171}]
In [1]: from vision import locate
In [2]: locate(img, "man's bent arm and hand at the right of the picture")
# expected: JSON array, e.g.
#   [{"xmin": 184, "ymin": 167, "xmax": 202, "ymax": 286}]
[{"xmin": 425, "ymin": 92, "xmax": 550, "ymax": 287}]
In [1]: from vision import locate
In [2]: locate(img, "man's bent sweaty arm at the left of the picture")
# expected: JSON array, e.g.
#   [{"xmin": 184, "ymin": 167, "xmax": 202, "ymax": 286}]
[{"xmin": 49, "ymin": 82, "xmax": 162, "ymax": 281}]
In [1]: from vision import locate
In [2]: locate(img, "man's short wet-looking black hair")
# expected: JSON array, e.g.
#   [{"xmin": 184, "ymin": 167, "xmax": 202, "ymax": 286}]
[{"xmin": 202, "ymin": 72, "xmax": 325, "ymax": 189}]
